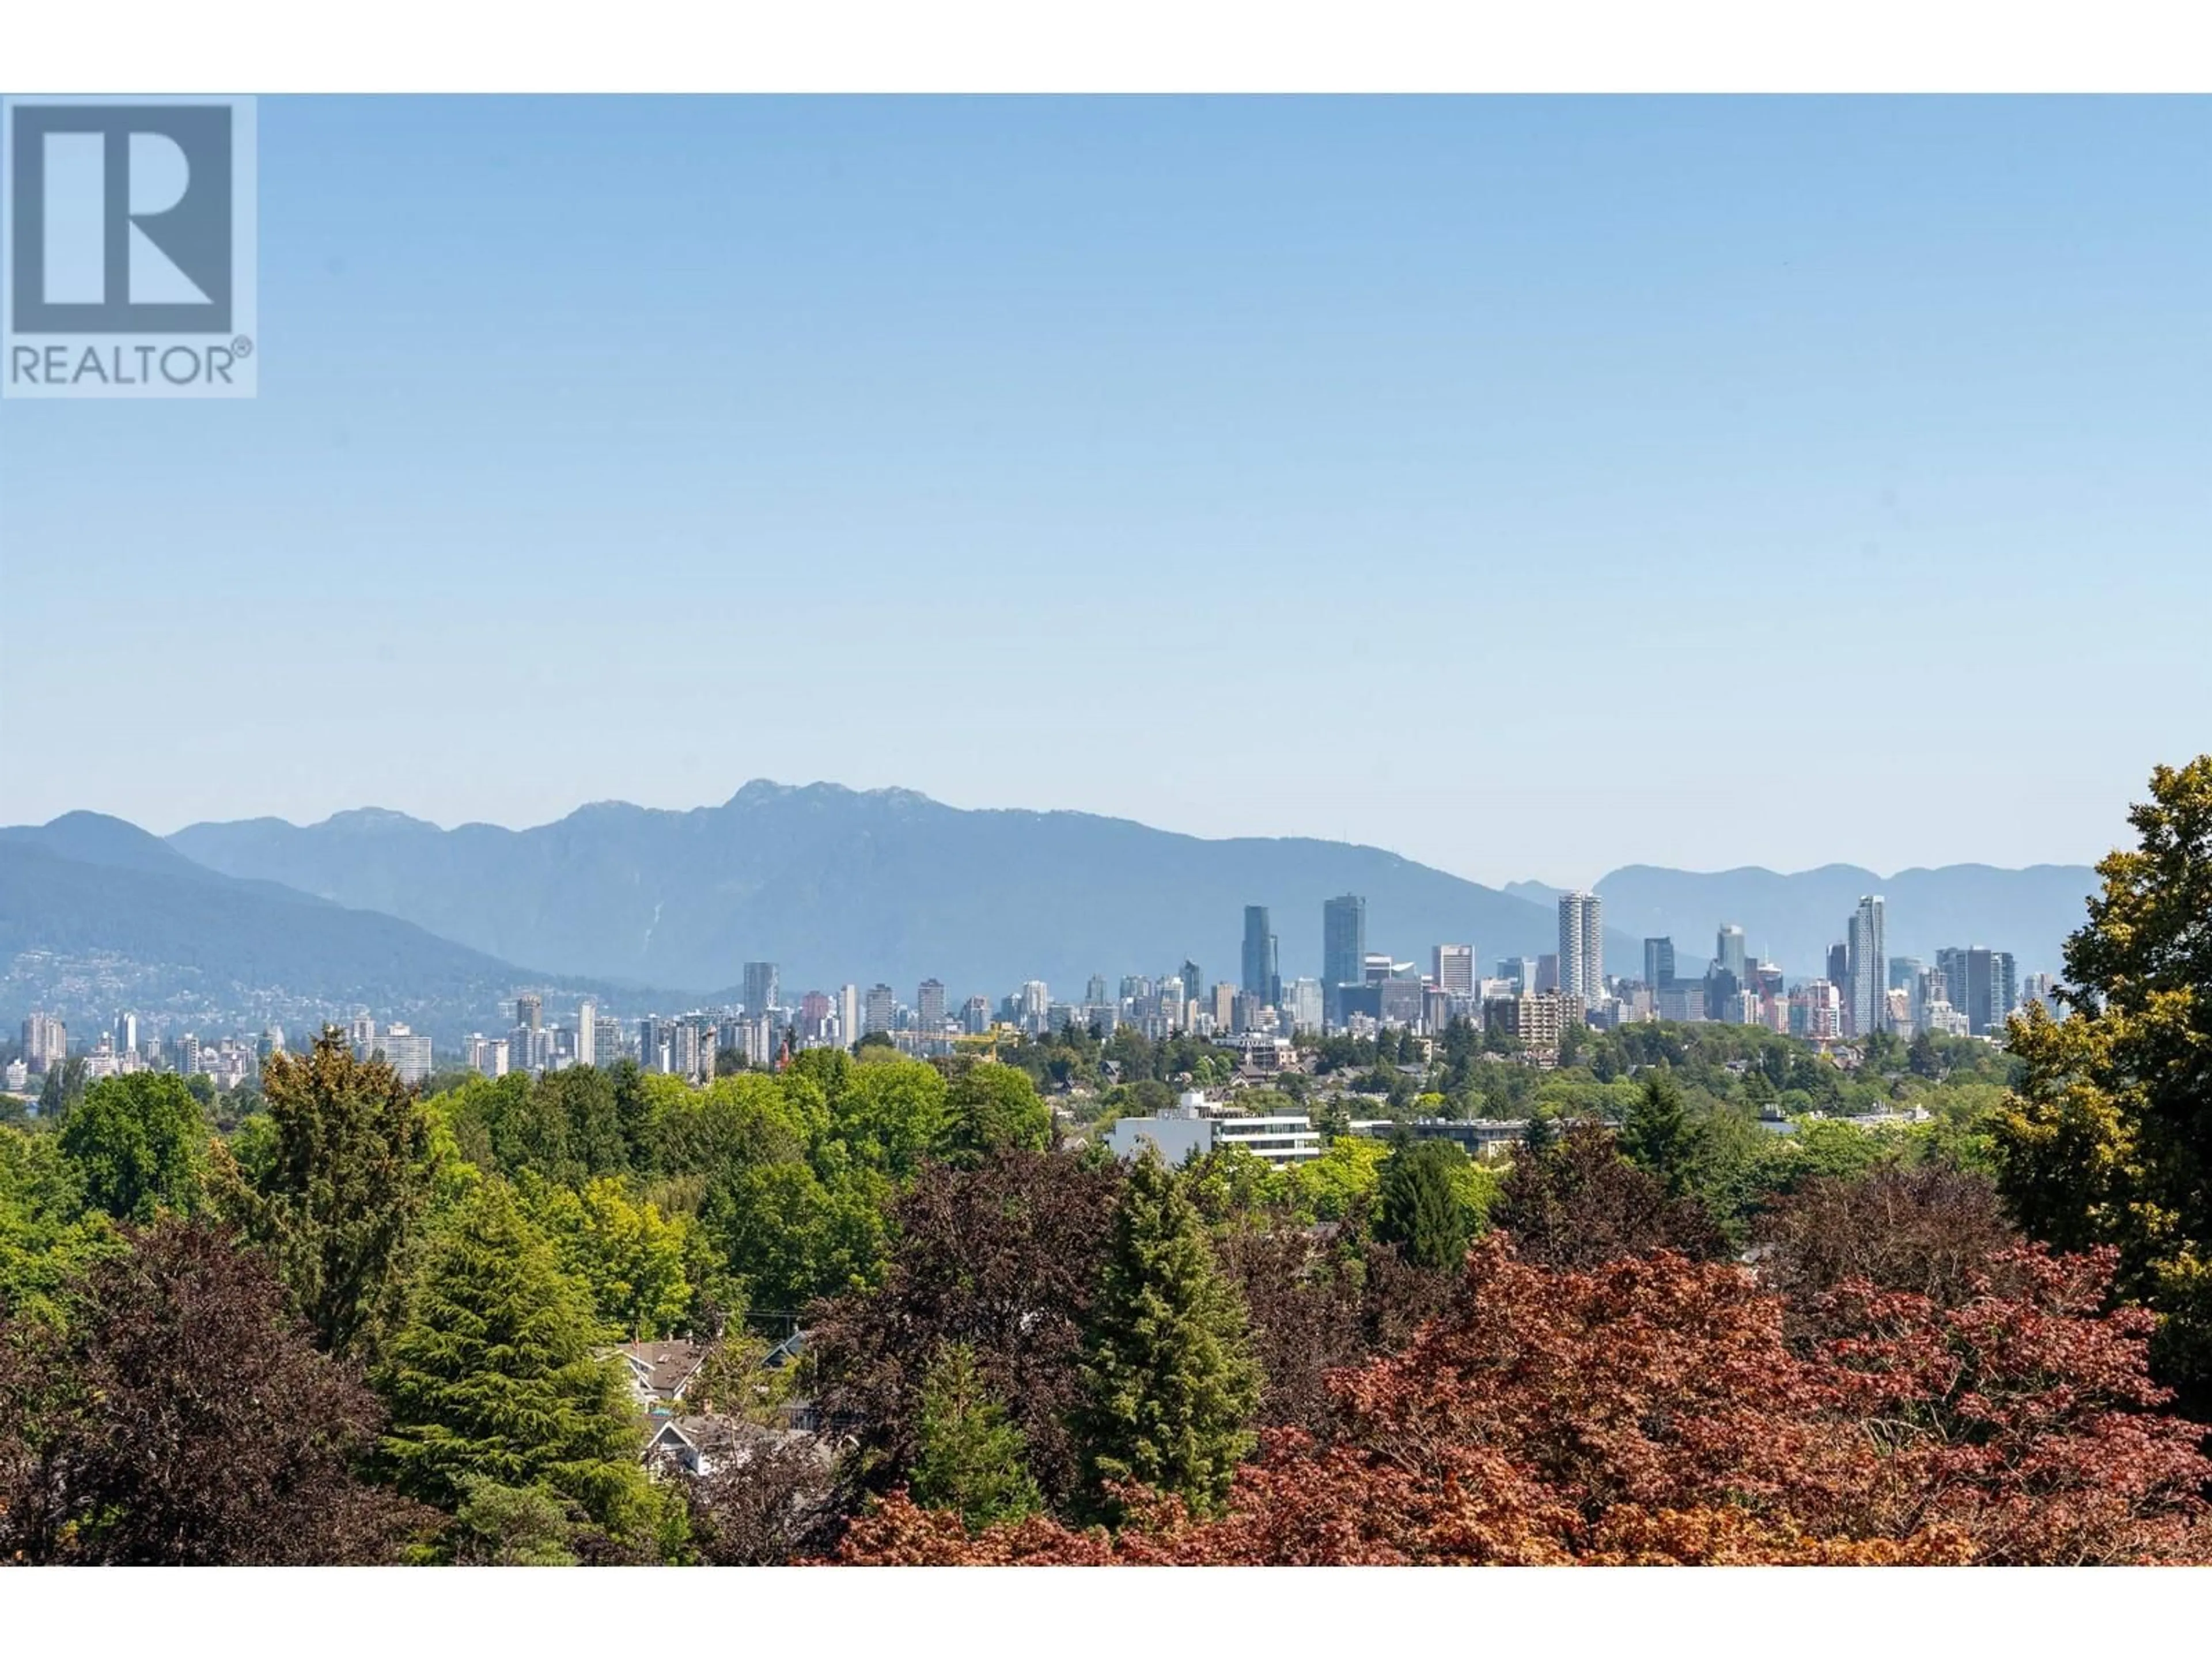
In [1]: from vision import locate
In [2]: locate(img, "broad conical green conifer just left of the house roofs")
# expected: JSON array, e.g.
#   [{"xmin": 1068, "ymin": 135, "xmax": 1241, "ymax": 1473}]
[{"xmin": 374, "ymin": 1181, "xmax": 659, "ymax": 1544}]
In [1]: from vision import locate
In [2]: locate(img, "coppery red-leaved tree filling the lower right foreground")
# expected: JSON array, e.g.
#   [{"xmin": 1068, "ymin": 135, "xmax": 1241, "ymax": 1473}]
[{"xmin": 838, "ymin": 1237, "xmax": 2212, "ymax": 1566}]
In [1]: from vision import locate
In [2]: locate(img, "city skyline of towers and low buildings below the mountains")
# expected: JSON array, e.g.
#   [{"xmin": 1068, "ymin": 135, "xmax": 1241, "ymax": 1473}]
[{"xmin": 21, "ymin": 871, "xmax": 2055, "ymax": 1086}]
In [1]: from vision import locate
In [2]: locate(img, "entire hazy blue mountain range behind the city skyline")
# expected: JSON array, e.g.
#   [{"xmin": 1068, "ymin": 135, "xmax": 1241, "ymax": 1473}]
[{"xmin": 0, "ymin": 781, "xmax": 2097, "ymax": 1035}]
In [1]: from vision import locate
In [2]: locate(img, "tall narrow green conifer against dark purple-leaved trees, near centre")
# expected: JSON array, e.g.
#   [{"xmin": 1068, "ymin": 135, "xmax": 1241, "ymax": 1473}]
[{"xmin": 1075, "ymin": 1148, "xmax": 1261, "ymax": 1515}]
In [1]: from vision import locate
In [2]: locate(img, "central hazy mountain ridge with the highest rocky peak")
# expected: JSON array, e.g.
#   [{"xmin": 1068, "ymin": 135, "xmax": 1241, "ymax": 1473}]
[{"xmin": 171, "ymin": 781, "xmax": 1639, "ymax": 1000}]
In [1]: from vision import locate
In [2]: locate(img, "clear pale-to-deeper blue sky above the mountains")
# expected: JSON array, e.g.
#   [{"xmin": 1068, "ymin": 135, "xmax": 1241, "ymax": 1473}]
[{"xmin": 0, "ymin": 97, "xmax": 2212, "ymax": 882}]
